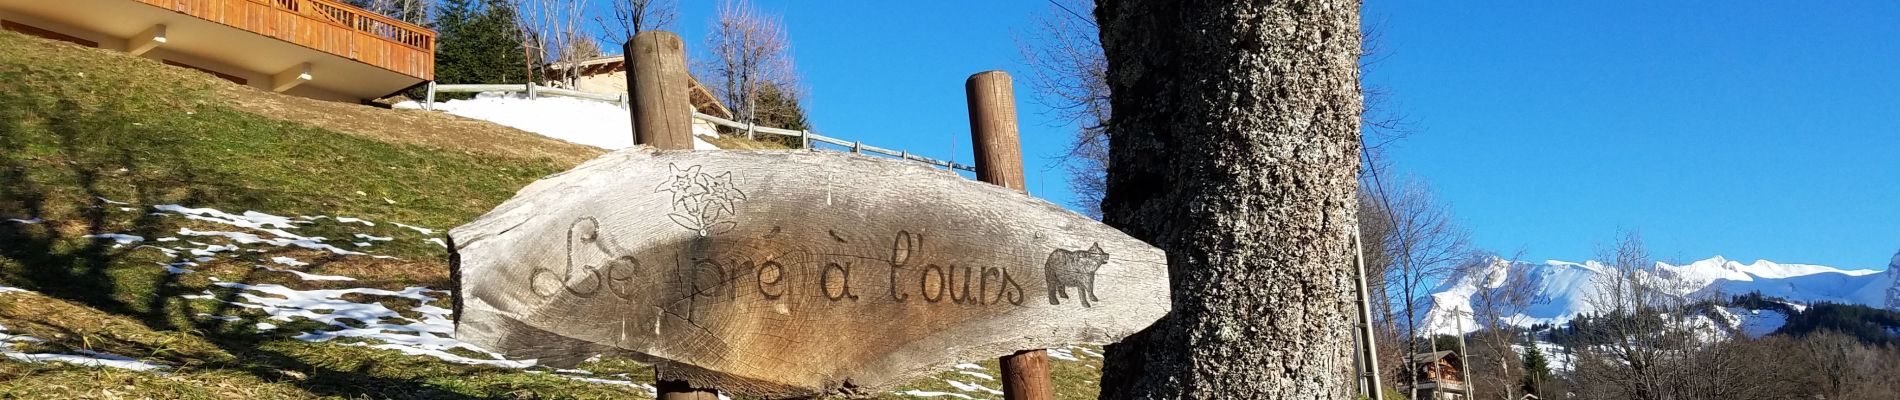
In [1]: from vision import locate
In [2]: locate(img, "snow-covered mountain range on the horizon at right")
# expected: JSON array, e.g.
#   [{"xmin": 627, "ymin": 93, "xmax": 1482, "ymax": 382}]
[{"xmin": 1421, "ymin": 254, "xmax": 1900, "ymax": 336}]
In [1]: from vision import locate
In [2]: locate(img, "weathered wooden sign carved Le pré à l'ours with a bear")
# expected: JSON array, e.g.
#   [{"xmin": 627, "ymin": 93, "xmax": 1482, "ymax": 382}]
[{"xmin": 448, "ymin": 148, "xmax": 1169, "ymax": 398}]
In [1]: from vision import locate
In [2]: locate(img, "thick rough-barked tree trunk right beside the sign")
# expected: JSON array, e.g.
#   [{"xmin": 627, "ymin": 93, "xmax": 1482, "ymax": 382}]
[{"xmin": 1096, "ymin": 0, "xmax": 1360, "ymax": 398}]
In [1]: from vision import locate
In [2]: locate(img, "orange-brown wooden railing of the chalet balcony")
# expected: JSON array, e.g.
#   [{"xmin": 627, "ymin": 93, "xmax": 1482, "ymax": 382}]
[{"xmin": 135, "ymin": 0, "xmax": 435, "ymax": 80}]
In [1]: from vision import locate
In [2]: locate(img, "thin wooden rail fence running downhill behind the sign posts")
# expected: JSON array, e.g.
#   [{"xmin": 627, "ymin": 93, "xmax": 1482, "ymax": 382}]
[{"xmin": 422, "ymin": 82, "xmax": 977, "ymax": 173}]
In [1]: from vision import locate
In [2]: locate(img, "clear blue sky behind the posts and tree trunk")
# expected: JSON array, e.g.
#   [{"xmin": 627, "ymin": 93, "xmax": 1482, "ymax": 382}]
[{"xmin": 615, "ymin": 0, "xmax": 1900, "ymax": 269}]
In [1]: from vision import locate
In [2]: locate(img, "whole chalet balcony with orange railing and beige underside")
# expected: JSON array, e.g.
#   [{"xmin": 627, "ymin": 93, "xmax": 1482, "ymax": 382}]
[{"xmin": 0, "ymin": 0, "xmax": 435, "ymax": 100}]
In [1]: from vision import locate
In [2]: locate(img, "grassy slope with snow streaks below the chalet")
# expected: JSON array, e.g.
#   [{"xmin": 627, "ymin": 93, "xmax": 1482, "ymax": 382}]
[{"xmin": 0, "ymin": 32, "xmax": 1100, "ymax": 398}]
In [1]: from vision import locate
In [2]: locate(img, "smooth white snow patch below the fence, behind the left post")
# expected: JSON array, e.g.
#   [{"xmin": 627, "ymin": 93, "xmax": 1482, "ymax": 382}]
[{"xmin": 395, "ymin": 93, "xmax": 718, "ymax": 150}]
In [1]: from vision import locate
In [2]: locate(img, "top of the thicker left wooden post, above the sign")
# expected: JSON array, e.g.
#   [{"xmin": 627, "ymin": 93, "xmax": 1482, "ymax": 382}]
[{"xmin": 623, "ymin": 30, "xmax": 694, "ymax": 150}]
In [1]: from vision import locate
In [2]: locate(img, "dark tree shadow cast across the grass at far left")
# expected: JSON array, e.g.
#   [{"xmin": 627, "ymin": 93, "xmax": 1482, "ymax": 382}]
[{"xmin": 0, "ymin": 90, "xmax": 482, "ymax": 398}]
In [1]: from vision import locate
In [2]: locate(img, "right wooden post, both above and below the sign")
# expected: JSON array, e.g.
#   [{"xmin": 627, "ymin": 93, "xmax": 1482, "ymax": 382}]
[{"xmin": 963, "ymin": 70, "xmax": 1056, "ymax": 400}]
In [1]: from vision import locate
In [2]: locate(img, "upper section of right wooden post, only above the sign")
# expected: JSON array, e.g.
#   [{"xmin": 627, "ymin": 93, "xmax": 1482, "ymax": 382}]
[{"xmin": 963, "ymin": 70, "xmax": 1024, "ymax": 190}]
